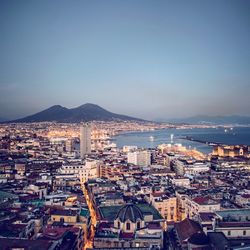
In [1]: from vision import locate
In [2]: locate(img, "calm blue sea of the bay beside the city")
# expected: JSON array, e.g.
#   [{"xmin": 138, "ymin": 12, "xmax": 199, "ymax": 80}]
[{"xmin": 113, "ymin": 127, "xmax": 250, "ymax": 154}]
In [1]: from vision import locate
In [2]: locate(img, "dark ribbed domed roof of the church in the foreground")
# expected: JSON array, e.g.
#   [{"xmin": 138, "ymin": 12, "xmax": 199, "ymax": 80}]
[{"xmin": 116, "ymin": 204, "xmax": 143, "ymax": 222}]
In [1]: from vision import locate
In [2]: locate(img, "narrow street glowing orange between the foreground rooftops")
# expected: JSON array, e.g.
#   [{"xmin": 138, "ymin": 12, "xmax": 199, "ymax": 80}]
[{"xmin": 83, "ymin": 185, "xmax": 97, "ymax": 249}]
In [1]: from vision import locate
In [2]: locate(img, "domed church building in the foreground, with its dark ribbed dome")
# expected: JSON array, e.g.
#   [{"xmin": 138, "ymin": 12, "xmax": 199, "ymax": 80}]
[{"xmin": 94, "ymin": 204, "xmax": 163, "ymax": 249}]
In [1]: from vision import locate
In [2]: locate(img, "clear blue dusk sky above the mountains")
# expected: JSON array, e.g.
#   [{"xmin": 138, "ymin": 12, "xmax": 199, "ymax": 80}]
[{"xmin": 0, "ymin": 0, "xmax": 250, "ymax": 119}]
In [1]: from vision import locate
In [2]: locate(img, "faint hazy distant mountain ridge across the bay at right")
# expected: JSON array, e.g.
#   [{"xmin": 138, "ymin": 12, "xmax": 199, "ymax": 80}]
[{"xmin": 167, "ymin": 115, "xmax": 250, "ymax": 125}]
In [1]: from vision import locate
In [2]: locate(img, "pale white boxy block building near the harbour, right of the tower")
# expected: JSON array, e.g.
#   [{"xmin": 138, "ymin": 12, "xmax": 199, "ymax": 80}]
[{"xmin": 127, "ymin": 150, "xmax": 151, "ymax": 166}]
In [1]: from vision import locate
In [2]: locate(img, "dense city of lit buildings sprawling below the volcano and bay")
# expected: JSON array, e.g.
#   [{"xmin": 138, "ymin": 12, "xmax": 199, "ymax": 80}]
[{"xmin": 0, "ymin": 121, "xmax": 250, "ymax": 250}]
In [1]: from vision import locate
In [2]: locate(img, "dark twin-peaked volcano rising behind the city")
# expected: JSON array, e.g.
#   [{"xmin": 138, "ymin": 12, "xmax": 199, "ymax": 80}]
[{"xmin": 7, "ymin": 103, "xmax": 143, "ymax": 122}]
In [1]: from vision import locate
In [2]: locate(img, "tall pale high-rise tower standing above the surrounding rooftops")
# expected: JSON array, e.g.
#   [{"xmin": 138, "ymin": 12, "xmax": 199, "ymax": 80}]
[{"xmin": 80, "ymin": 123, "xmax": 91, "ymax": 158}]
